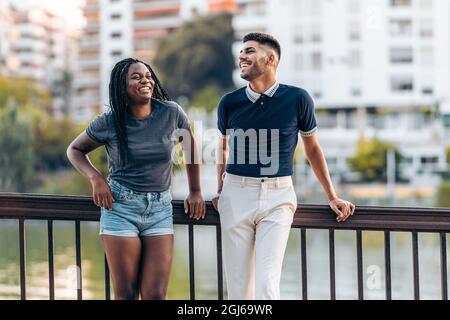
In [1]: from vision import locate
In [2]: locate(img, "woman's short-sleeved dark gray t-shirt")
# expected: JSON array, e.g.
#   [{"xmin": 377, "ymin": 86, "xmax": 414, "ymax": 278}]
[{"xmin": 86, "ymin": 99, "xmax": 189, "ymax": 192}]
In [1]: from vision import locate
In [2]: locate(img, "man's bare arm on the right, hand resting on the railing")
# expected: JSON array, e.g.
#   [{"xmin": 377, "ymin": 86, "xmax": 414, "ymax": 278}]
[{"xmin": 302, "ymin": 134, "xmax": 355, "ymax": 222}]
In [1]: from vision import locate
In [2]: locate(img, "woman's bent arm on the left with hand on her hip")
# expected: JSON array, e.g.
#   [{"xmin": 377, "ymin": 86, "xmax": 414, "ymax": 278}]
[{"xmin": 66, "ymin": 132, "xmax": 114, "ymax": 210}]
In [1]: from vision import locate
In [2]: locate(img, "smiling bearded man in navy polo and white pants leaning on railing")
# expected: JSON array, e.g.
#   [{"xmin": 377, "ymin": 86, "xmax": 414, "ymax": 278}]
[{"xmin": 213, "ymin": 33, "xmax": 355, "ymax": 299}]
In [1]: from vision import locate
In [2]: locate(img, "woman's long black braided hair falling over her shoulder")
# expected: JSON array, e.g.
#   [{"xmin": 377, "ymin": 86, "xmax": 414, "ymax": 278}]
[{"xmin": 109, "ymin": 58, "xmax": 170, "ymax": 164}]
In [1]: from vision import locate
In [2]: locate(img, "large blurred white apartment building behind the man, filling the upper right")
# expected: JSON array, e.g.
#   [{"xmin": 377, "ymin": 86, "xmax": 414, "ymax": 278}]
[{"xmin": 233, "ymin": 0, "xmax": 450, "ymax": 179}]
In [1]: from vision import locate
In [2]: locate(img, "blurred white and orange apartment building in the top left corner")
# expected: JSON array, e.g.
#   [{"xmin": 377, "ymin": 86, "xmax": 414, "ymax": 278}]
[{"xmin": 0, "ymin": 0, "xmax": 77, "ymax": 115}]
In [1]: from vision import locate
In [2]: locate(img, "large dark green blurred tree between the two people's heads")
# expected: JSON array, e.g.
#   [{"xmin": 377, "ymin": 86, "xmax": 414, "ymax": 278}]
[{"xmin": 154, "ymin": 13, "xmax": 235, "ymax": 99}]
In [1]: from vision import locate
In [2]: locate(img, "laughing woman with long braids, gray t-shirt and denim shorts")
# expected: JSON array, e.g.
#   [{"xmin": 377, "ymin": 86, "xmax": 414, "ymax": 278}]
[{"xmin": 67, "ymin": 59, "xmax": 205, "ymax": 299}]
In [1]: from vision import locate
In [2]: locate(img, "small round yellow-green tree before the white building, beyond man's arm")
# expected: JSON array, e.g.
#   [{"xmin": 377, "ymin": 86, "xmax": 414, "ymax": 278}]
[{"xmin": 348, "ymin": 139, "xmax": 401, "ymax": 182}]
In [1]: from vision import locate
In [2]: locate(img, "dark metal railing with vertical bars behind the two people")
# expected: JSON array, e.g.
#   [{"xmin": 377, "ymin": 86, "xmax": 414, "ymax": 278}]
[{"xmin": 0, "ymin": 193, "xmax": 450, "ymax": 300}]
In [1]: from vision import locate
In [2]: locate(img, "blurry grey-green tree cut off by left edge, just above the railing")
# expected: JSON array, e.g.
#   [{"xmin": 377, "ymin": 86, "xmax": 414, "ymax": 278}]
[{"xmin": 0, "ymin": 105, "xmax": 34, "ymax": 192}]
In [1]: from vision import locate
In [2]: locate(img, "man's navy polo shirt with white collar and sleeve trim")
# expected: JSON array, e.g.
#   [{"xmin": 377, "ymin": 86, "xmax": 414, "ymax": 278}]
[{"xmin": 217, "ymin": 83, "xmax": 317, "ymax": 177}]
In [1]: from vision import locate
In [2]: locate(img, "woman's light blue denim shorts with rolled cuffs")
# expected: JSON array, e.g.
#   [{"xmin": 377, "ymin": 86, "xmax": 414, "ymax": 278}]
[{"xmin": 100, "ymin": 180, "xmax": 173, "ymax": 237}]
